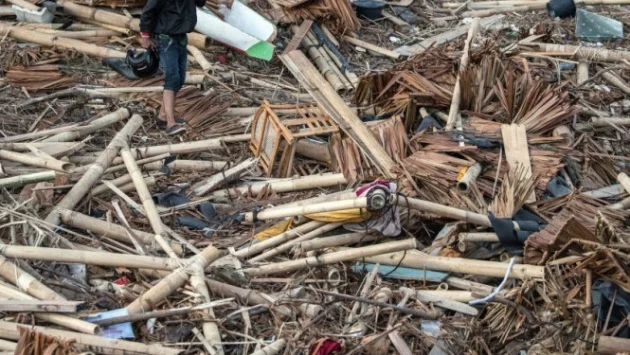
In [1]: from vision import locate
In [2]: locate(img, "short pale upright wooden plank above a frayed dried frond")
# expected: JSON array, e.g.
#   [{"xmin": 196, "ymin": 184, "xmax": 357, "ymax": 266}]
[{"xmin": 501, "ymin": 124, "xmax": 536, "ymax": 203}]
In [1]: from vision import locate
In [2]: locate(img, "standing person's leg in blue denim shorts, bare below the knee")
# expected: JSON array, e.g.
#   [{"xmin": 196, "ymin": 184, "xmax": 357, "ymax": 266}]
[{"xmin": 160, "ymin": 39, "xmax": 181, "ymax": 130}]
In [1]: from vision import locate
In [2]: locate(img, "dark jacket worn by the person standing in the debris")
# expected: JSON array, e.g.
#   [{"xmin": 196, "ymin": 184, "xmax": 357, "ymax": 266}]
[{"xmin": 140, "ymin": 0, "xmax": 206, "ymax": 35}]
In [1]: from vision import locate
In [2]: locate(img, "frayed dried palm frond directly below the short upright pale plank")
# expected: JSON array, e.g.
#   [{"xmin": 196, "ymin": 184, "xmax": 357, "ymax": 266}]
[{"xmin": 489, "ymin": 165, "xmax": 540, "ymax": 218}]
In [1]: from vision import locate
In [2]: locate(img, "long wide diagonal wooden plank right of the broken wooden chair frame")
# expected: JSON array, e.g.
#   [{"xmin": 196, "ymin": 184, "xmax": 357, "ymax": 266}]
[{"xmin": 280, "ymin": 51, "xmax": 396, "ymax": 179}]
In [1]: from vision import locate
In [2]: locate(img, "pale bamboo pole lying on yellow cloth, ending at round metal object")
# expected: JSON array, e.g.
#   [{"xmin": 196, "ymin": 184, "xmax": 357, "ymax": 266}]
[{"xmin": 245, "ymin": 197, "xmax": 367, "ymax": 222}]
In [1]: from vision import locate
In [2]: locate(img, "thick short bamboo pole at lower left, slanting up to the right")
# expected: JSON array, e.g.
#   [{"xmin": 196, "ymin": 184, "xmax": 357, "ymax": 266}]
[{"xmin": 127, "ymin": 245, "xmax": 221, "ymax": 314}]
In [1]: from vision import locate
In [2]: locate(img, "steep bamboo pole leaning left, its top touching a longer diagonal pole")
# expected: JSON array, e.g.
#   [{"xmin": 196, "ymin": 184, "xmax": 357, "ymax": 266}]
[{"xmin": 120, "ymin": 144, "xmax": 177, "ymax": 258}]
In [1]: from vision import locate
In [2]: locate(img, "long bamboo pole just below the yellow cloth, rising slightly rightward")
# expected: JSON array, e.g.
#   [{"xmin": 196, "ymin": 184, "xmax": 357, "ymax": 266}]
[{"xmin": 243, "ymin": 239, "xmax": 417, "ymax": 276}]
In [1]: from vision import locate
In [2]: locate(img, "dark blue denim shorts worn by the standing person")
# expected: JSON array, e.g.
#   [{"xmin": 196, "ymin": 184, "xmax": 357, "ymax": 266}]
[{"xmin": 158, "ymin": 37, "xmax": 188, "ymax": 91}]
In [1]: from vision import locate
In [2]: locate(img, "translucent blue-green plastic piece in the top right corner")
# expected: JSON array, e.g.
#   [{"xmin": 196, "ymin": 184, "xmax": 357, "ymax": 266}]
[{"xmin": 575, "ymin": 9, "xmax": 623, "ymax": 42}]
